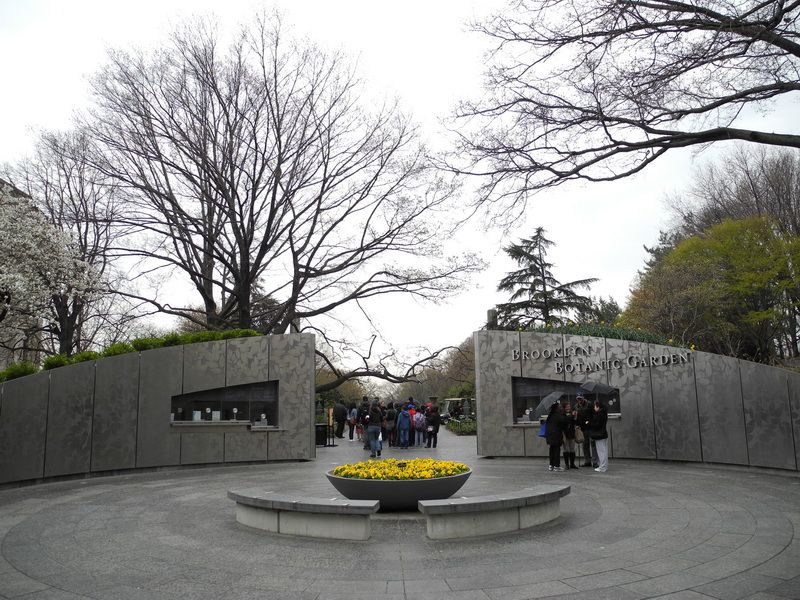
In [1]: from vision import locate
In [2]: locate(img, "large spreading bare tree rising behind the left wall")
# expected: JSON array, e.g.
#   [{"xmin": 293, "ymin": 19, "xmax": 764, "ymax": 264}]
[{"xmin": 88, "ymin": 18, "xmax": 480, "ymax": 342}]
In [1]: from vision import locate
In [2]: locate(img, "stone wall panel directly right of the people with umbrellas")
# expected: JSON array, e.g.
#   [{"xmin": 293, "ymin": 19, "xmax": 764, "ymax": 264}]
[{"xmin": 606, "ymin": 340, "xmax": 656, "ymax": 458}]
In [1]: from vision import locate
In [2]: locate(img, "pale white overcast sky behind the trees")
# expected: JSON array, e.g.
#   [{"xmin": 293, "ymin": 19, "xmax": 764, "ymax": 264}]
[{"xmin": 0, "ymin": 0, "xmax": 800, "ymax": 360}]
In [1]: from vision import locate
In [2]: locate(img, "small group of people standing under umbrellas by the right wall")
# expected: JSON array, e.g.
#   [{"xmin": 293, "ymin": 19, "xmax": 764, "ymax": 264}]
[{"xmin": 544, "ymin": 395, "xmax": 608, "ymax": 473}]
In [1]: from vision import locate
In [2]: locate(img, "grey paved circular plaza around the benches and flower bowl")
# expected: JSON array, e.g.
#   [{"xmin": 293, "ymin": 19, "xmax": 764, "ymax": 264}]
[{"xmin": 0, "ymin": 432, "xmax": 800, "ymax": 600}]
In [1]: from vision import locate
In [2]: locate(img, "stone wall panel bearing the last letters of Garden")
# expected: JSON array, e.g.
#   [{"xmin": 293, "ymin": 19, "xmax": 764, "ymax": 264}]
[{"xmin": 648, "ymin": 344, "xmax": 702, "ymax": 461}]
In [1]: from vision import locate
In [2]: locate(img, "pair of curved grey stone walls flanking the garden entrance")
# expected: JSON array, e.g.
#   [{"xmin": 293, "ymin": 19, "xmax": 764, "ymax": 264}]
[{"xmin": 0, "ymin": 331, "xmax": 800, "ymax": 485}]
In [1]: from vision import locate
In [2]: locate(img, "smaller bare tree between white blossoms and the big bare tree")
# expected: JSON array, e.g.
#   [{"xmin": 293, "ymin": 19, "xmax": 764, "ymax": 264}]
[{"xmin": 10, "ymin": 130, "xmax": 136, "ymax": 356}]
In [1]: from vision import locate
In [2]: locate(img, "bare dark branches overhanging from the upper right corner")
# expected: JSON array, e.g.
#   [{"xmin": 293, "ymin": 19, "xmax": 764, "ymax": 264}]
[{"xmin": 451, "ymin": 0, "xmax": 800, "ymax": 216}]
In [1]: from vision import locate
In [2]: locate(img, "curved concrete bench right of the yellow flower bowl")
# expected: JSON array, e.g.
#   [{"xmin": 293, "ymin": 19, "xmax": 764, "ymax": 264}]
[{"xmin": 418, "ymin": 485, "xmax": 570, "ymax": 540}]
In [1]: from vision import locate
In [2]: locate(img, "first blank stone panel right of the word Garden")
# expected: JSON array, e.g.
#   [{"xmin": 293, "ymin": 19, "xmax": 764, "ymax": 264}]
[{"xmin": 694, "ymin": 352, "xmax": 748, "ymax": 465}]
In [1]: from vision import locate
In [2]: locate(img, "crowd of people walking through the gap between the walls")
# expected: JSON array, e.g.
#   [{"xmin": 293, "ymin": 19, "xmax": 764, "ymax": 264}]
[{"xmin": 333, "ymin": 397, "xmax": 442, "ymax": 458}]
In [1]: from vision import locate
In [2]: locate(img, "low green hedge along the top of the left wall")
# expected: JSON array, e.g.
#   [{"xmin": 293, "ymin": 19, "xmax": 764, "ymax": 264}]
[{"xmin": 0, "ymin": 329, "xmax": 261, "ymax": 381}]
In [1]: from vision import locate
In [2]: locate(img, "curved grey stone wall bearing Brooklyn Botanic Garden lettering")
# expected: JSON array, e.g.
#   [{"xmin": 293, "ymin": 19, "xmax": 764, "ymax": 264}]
[{"xmin": 474, "ymin": 331, "xmax": 800, "ymax": 471}]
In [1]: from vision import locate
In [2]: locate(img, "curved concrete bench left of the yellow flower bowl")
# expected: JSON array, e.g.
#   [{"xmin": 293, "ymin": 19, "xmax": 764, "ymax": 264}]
[{"xmin": 228, "ymin": 489, "xmax": 379, "ymax": 540}]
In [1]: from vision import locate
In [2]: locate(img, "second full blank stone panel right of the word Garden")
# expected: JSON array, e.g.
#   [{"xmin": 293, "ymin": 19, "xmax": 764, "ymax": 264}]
[{"xmin": 739, "ymin": 360, "xmax": 795, "ymax": 469}]
